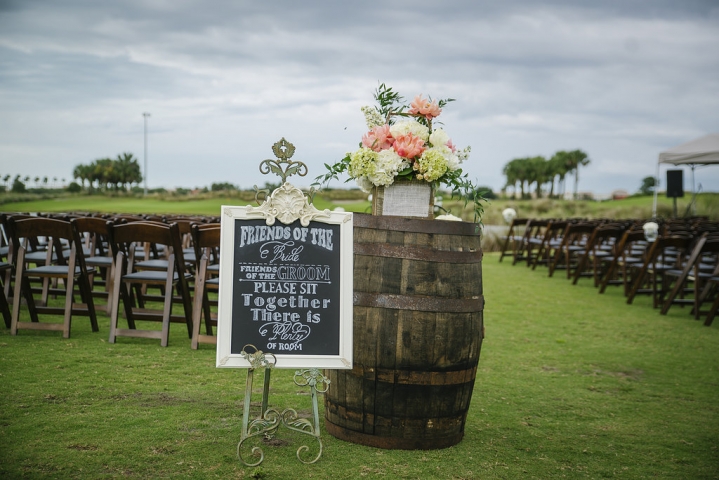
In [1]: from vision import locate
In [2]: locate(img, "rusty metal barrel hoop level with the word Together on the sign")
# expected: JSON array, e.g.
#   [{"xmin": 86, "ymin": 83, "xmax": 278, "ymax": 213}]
[{"xmin": 353, "ymin": 292, "xmax": 484, "ymax": 313}]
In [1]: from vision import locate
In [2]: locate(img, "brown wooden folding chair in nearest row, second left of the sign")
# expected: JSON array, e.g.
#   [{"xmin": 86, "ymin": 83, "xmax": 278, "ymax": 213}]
[{"xmin": 109, "ymin": 222, "xmax": 192, "ymax": 347}]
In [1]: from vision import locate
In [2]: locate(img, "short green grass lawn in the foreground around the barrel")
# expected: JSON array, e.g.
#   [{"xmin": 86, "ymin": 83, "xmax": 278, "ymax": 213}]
[{"xmin": 0, "ymin": 254, "xmax": 719, "ymax": 480}]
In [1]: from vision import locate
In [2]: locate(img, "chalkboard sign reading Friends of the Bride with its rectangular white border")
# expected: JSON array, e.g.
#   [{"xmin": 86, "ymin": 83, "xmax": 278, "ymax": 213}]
[{"xmin": 217, "ymin": 206, "xmax": 352, "ymax": 368}]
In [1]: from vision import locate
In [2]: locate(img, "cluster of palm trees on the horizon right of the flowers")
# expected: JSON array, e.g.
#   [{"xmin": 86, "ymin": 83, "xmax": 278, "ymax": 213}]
[{"xmin": 502, "ymin": 150, "xmax": 590, "ymax": 199}]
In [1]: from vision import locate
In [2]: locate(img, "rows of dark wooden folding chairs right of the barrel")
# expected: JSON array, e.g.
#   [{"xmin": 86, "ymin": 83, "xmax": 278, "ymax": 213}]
[{"xmin": 499, "ymin": 218, "xmax": 719, "ymax": 326}]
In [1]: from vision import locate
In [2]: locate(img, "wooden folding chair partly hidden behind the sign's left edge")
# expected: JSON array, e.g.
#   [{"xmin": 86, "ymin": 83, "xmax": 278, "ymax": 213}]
[{"xmin": 191, "ymin": 224, "xmax": 220, "ymax": 350}]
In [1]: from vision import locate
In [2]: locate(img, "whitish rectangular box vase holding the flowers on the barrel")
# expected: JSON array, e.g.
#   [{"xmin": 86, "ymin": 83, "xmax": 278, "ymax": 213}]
[{"xmin": 372, "ymin": 180, "xmax": 434, "ymax": 218}]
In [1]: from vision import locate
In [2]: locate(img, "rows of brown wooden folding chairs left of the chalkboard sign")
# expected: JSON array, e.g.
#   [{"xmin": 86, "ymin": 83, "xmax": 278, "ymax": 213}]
[{"xmin": 0, "ymin": 213, "xmax": 220, "ymax": 349}]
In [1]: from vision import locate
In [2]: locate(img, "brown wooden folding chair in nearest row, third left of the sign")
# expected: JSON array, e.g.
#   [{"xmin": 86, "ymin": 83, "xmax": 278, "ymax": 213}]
[{"xmin": 9, "ymin": 217, "xmax": 99, "ymax": 338}]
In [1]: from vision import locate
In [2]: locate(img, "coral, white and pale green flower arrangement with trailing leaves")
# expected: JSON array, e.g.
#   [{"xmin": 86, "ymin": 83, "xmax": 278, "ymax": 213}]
[{"xmin": 315, "ymin": 83, "xmax": 484, "ymax": 220}]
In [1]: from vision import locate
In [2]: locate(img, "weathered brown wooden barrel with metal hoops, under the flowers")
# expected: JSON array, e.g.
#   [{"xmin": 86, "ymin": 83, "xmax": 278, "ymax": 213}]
[{"xmin": 325, "ymin": 214, "xmax": 484, "ymax": 449}]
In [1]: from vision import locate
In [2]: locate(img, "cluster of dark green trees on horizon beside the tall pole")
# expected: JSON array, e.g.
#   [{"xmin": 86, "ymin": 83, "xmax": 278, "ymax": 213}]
[{"xmin": 72, "ymin": 152, "xmax": 142, "ymax": 190}]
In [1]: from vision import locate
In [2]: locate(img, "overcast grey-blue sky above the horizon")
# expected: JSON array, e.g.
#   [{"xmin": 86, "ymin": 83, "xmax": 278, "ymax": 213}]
[{"xmin": 0, "ymin": 0, "xmax": 719, "ymax": 193}]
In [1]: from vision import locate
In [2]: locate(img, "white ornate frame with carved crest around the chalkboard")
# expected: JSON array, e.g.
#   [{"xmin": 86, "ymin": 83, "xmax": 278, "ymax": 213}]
[{"xmin": 216, "ymin": 182, "xmax": 353, "ymax": 369}]
